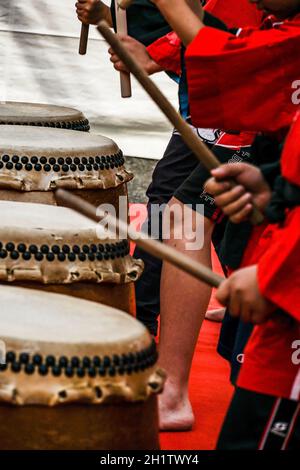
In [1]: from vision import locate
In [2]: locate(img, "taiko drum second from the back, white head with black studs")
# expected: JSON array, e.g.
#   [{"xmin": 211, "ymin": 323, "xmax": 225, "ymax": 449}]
[{"xmin": 0, "ymin": 125, "xmax": 132, "ymax": 208}]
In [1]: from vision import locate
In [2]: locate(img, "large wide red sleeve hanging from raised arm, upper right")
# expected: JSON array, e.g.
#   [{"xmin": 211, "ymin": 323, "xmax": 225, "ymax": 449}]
[{"xmin": 186, "ymin": 15, "xmax": 300, "ymax": 132}]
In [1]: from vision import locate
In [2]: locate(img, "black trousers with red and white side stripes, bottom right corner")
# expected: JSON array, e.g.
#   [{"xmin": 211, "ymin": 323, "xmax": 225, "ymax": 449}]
[{"xmin": 217, "ymin": 388, "xmax": 300, "ymax": 450}]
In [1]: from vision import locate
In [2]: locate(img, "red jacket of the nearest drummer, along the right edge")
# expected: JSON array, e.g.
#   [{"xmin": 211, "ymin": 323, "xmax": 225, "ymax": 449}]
[{"xmin": 238, "ymin": 113, "xmax": 300, "ymax": 400}]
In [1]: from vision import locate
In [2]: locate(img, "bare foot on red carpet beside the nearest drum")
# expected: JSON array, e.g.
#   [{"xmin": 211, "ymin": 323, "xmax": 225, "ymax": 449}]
[{"xmin": 158, "ymin": 381, "xmax": 195, "ymax": 431}]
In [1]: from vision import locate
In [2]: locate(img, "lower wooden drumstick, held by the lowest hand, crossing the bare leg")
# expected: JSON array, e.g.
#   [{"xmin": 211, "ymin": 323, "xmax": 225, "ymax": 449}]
[{"xmin": 55, "ymin": 189, "xmax": 224, "ymax": 287}]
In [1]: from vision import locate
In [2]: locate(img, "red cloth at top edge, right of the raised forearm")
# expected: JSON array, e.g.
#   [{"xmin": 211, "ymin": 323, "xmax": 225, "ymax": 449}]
[{"xmin": 204, "ymin": 0, "xmax": 263, "ymax": 28}]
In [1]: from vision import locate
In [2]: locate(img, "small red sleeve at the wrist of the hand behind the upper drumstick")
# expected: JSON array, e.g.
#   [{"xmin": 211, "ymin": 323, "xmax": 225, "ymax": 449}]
[{"xmin": 147, "ymin": 32, "xmax": 181, "ymax": 75}]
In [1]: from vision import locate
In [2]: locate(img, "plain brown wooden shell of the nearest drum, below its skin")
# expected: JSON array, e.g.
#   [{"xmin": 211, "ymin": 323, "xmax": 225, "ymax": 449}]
[{"xmin": 0, "ymin": 396, "xmax": 159, "ymax": 451}]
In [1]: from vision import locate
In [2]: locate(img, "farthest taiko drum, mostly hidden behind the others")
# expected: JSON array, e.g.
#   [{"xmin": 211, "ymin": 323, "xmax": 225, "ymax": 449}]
[{"xmin": 0, "ymin": 101, "xmax": 90, "ymax": 132}]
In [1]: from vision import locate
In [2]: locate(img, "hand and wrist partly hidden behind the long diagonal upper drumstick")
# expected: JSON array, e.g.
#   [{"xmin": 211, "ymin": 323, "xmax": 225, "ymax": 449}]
[{"xmin": 108, "ymin": 34, "xmax": 162, "ymax": 75}]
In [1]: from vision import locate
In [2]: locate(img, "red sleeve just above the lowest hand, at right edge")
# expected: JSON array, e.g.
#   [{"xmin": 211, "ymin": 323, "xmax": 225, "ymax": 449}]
[{"xmin": 258, "ymin": 207, "xmax": 300, "ymax": 321}]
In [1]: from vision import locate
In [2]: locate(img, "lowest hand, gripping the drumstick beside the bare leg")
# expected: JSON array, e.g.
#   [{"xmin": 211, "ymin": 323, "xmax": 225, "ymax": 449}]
[{"xmin": 216, "ymin": 266, "xmax": 276, "ymax": 324}]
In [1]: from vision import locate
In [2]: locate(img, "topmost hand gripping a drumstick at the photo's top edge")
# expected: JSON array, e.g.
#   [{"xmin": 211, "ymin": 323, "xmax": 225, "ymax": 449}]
[{"xmin": 75, "ymin": 0, "xmax": 112, "ymax": 26}]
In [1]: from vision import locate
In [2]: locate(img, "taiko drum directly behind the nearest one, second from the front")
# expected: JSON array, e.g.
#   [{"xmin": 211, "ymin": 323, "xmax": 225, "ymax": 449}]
[{"xmin": 0, "ymin": 201, "xmax": 143, "ymax": 314}]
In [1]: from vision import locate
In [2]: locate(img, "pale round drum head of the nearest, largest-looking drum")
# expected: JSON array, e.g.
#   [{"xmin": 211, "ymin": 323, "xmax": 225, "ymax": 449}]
[{"xmin": 0, "ymin": 285, "xmax": 146, "ymax": 357}]
